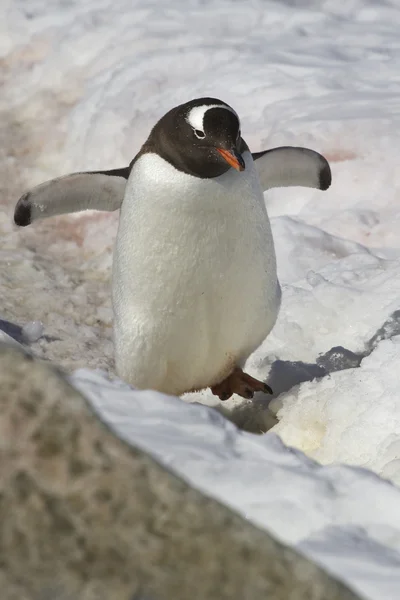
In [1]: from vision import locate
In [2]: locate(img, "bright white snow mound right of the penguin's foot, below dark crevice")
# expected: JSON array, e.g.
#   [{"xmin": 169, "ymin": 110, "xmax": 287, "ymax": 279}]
[{"xmin": 272, "ymin": 336, "xmax": 400, "ymax": 485}]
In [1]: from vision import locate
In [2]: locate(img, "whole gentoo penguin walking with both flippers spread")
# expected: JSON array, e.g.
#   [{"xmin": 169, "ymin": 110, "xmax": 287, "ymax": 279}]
[{"xmin": 14, "ymin": 98, "xmax": 331, "ymax": 400}]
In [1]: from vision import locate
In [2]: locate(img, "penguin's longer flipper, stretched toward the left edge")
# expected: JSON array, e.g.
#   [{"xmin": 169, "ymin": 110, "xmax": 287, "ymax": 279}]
[{"xmin": 14, "ymin": 167, "xmax": 130, "ymax": 227}]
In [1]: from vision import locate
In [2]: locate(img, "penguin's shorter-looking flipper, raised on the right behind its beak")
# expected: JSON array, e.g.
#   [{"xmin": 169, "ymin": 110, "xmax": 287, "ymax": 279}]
[{"xmin": 252, "ymin": 146, "xmax": 332, "ymax": 191}]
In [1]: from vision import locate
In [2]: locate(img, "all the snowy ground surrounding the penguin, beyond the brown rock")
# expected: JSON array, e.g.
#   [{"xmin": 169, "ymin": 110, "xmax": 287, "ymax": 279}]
[{"xmin": 0, "ymin": 0, "xmax": 400, "ymax": 600}]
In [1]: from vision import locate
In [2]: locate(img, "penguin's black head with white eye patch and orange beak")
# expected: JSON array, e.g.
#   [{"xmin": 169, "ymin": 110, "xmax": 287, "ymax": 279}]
[{"xmin": 143, "ymin": 98, "xmax": 247, "ymax": 178}]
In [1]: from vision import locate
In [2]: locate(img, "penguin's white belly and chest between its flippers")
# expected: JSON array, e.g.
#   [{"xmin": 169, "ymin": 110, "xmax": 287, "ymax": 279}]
[{"xmin": 113, "ymin": 152, "xmax": 280, "ymax": 395}]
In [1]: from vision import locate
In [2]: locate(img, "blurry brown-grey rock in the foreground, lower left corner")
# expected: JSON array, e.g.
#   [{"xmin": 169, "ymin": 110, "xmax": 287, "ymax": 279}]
[{"xmin": 0, "ymin": 345, "xmax": 357, "ymax": 600}]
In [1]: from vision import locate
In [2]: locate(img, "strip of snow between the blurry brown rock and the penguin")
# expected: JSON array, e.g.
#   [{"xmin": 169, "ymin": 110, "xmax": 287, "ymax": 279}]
[{"xmin": 70, "ymin": 366, "xmax": 400, "ymax": 600}]
